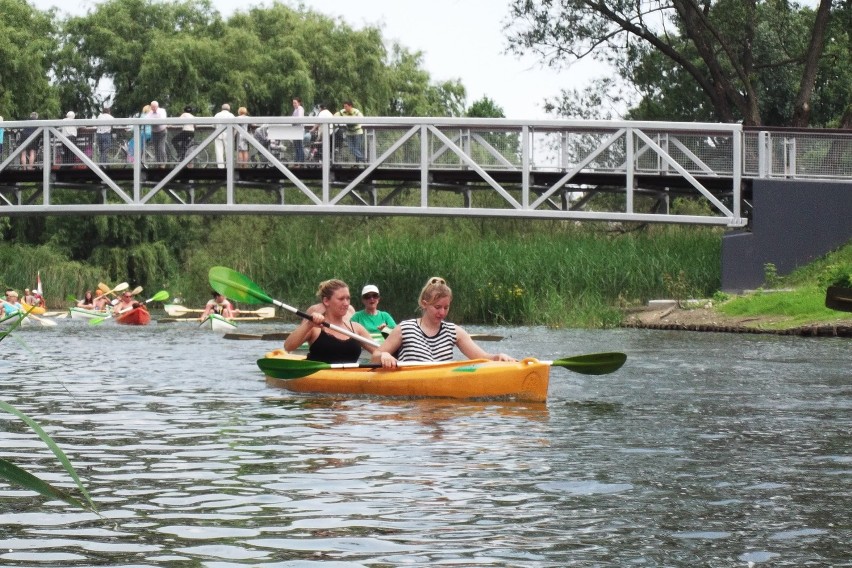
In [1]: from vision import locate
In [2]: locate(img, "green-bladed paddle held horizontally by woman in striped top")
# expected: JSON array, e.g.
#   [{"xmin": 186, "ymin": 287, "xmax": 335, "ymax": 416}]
[{"xmin": 257, "ymin": 353, "xmax": 627, "ymax": 379}]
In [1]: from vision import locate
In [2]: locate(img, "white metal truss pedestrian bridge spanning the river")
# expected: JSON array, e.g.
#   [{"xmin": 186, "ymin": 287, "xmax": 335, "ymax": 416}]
[{"xmin": 0, "ymin": 117, "xmax": 852, "ymax": 227}]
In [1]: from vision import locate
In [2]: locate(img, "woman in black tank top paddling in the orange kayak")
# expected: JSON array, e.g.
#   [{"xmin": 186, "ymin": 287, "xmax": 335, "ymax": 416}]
[{"xmin": 284, "ymin": 279, "xmax": 375, "ymax": 363}]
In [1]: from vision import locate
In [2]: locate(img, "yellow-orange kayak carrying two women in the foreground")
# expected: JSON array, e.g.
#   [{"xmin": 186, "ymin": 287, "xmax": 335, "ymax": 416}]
[{"xmin": 258, "ymin": 349, "xmax": 550, "ymax": 402}]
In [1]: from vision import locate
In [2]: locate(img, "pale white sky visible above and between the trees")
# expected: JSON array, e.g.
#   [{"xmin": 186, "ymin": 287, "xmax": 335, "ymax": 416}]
[{"xmin": 31, "ymin": 0, "xmax": 606, "ymax": 120}]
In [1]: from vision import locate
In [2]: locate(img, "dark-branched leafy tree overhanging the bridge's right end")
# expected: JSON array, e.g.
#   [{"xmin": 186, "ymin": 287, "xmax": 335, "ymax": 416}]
[{"xmin": 508, "ymin": 0, "xmax": 849, "ymax": 126}]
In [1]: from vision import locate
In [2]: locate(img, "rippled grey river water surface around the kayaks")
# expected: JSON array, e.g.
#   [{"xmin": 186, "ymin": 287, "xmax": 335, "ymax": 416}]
[{"xmin": 0, "ymin": 321, "xmax": 852, "ymax": 567}]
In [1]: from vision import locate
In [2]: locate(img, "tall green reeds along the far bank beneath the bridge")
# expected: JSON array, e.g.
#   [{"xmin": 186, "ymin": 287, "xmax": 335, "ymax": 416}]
[{"xmin": 0, "ymin": 217, "xmax": 721, "ymax": 327}]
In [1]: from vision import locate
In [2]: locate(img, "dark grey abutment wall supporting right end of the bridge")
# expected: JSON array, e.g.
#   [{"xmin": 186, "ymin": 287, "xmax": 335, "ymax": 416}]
[{"xmin": 722, "ymin": 180, "xmax": 852, "ymax": 292}]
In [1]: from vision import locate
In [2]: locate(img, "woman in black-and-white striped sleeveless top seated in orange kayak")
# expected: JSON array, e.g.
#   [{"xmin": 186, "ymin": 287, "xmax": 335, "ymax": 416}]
[{"xmin": 372, "ymin": 277, "xmax": 516, "ymax": 368}]
